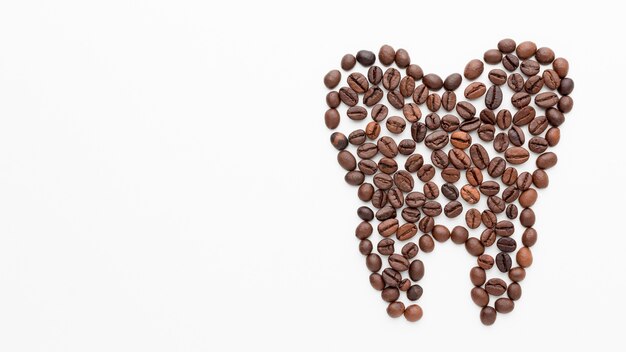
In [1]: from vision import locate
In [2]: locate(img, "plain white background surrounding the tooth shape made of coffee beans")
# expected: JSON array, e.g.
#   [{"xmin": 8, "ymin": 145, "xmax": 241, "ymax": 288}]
[{"xmin": 0, "ymin": 0, "xmax": 626, "ymax": 352}]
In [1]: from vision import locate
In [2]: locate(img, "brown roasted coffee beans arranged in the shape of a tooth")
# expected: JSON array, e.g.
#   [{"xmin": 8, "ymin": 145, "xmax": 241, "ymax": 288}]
[{"xmin": 324, "ymin": 39, "xmax": 574, "ymax": 325}]
